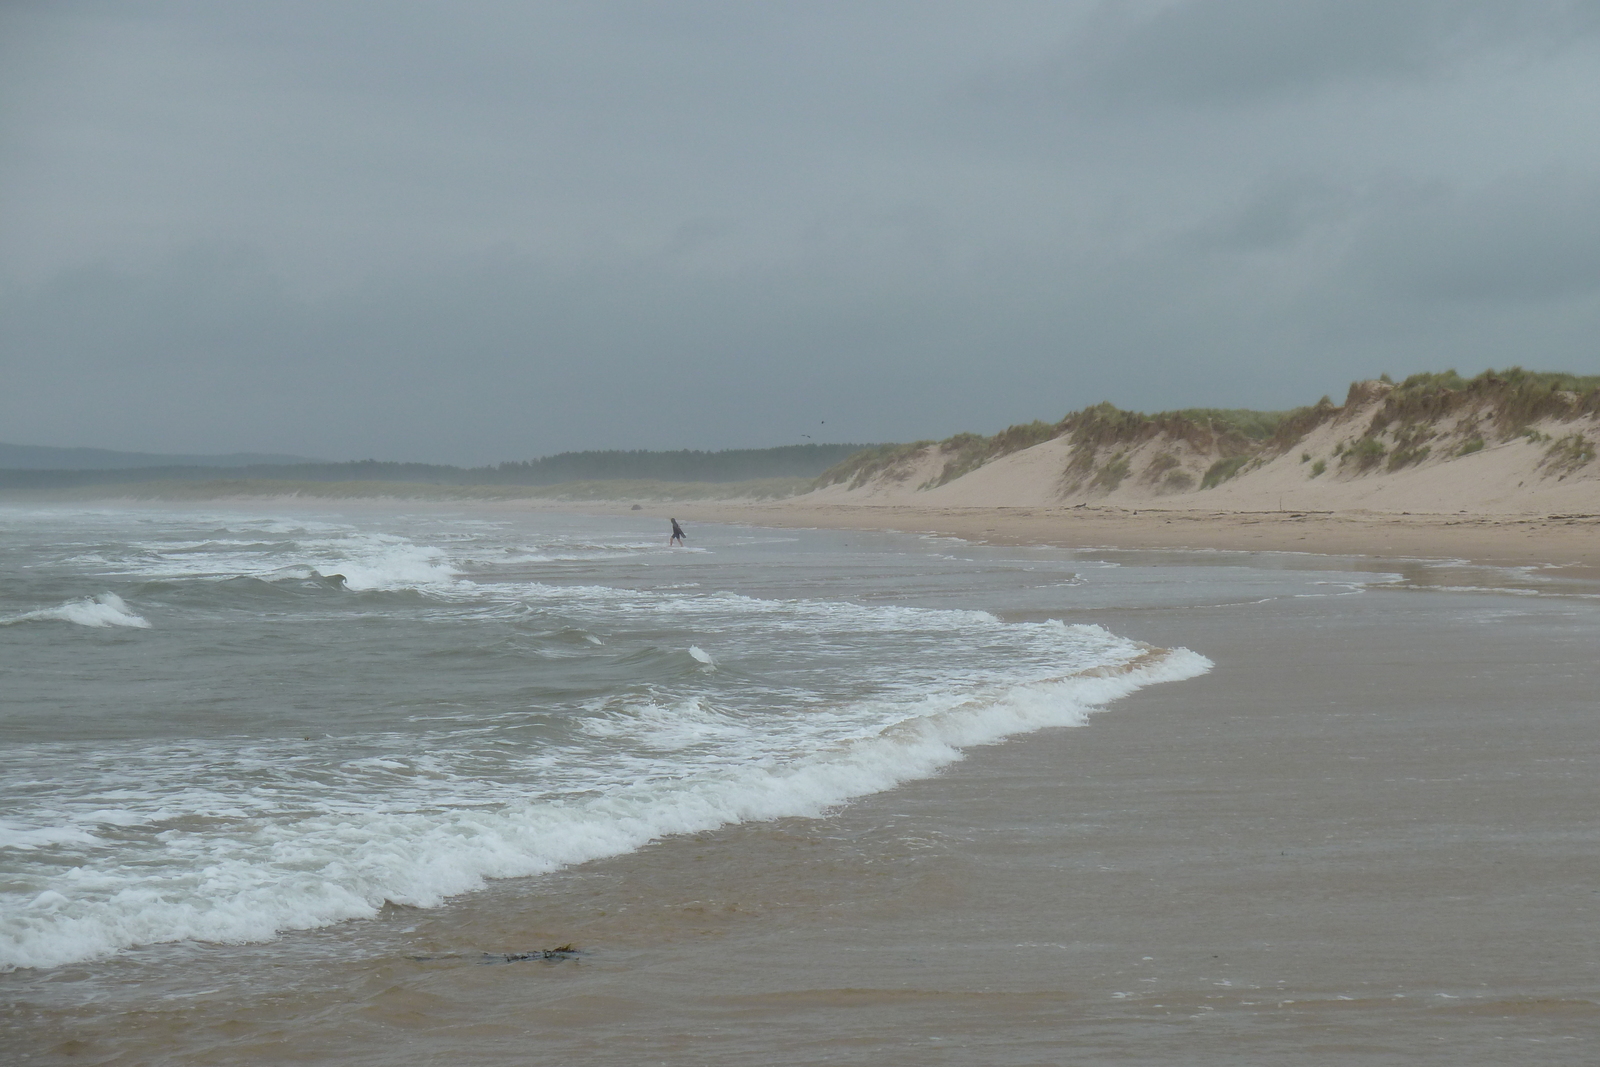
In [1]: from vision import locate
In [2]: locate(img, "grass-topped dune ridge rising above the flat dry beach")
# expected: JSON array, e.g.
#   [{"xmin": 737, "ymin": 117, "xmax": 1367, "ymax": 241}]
[{"xmin": 812, "ymin": 370, "xmax": 1600, "ymax": 515}]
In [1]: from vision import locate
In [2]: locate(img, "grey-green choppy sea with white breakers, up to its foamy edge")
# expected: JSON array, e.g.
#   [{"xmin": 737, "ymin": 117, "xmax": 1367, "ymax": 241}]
[{"xmin": 0, "ymin": 509, "xmax": 1209, "ymax": 968}]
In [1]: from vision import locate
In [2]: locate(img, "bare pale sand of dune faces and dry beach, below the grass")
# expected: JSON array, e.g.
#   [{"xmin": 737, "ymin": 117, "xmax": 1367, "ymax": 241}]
[{"xmin": 723, "ymin": 382, "xmax": 1600, "ymax": 576}]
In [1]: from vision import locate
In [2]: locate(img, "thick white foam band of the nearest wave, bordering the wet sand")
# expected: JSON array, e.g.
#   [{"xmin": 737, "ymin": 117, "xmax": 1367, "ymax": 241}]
[{"xmin": 0, "ymin": 639, "xmax": 1211, "ymax": 968}]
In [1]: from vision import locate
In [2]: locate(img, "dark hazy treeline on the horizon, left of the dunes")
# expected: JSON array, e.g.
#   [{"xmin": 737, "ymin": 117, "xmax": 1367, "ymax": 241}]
[{"xmin": 0, "ymin": 445, "xmax": 869, "ymax": 490}]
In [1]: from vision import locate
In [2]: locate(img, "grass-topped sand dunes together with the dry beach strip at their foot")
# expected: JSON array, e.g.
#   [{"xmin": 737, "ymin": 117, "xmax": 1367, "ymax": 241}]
[{"xmin": 696, "ymin": 374, "xmax": 1600, "ymax": 581}]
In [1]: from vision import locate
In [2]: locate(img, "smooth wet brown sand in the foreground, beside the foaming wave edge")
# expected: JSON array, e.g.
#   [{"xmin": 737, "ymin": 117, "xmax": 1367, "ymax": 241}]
[{"xmin": 6, "ymin": 543, "xmax": 1600, "ymax": 1065}]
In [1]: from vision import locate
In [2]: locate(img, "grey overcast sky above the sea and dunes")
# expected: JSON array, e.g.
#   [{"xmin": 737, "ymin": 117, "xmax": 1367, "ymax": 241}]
[{"xmin": 0, "ymin": 0, "xmax": 1600, "ymax": 464}]
